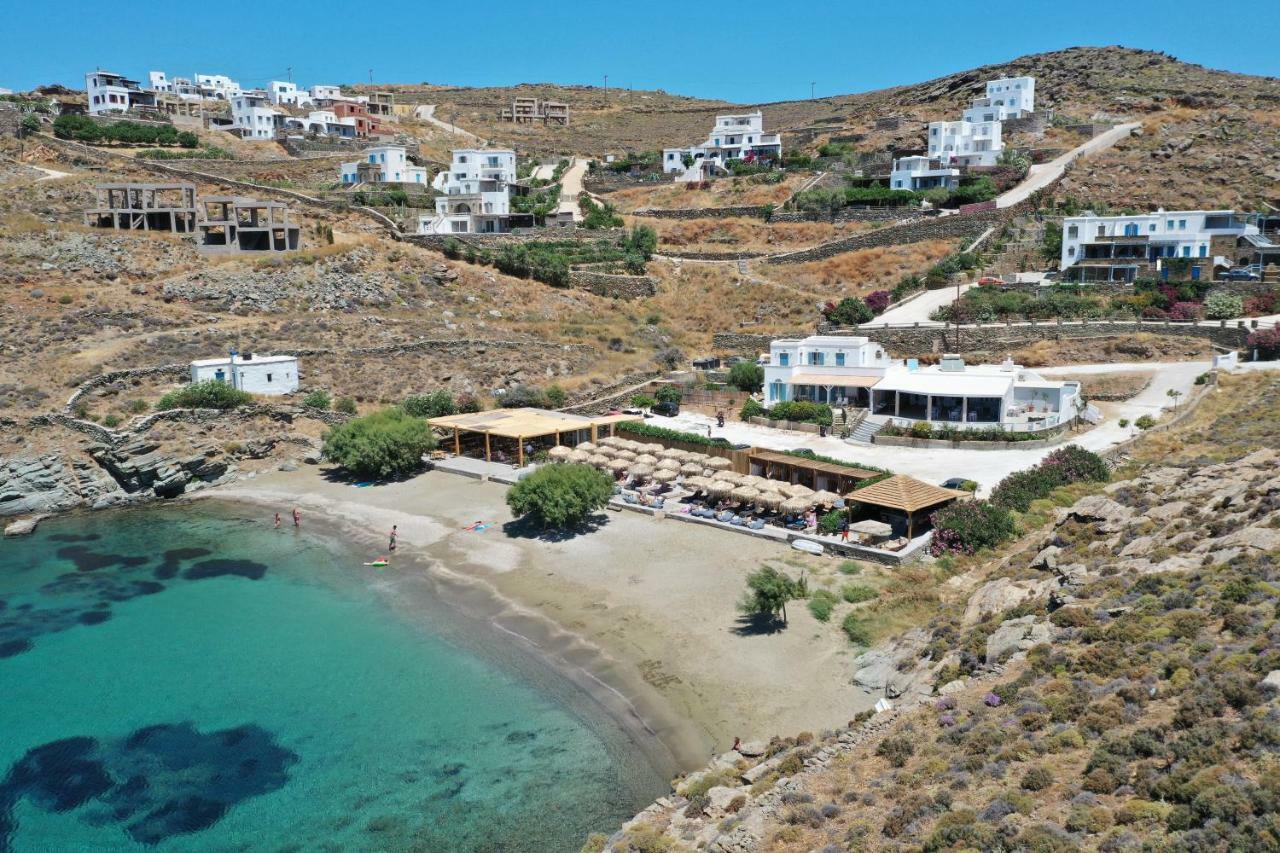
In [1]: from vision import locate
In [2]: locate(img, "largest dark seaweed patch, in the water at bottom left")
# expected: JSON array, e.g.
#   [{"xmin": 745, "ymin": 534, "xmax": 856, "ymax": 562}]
[{"xmin": 0, "ymin": 722, "xmax": 298, "ymax": 850}]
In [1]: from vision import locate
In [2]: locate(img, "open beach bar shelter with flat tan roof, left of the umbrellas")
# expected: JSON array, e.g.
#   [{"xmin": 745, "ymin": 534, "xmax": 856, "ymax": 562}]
[{"xmin": 426, "ymin": 409, "xmax": 643, "ymax": 467}]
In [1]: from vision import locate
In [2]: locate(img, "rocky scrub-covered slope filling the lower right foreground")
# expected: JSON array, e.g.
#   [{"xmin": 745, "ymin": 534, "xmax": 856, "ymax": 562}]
[{"xmin": 601, "ymin": 374, "xmax": 1280, "ymax": 852}]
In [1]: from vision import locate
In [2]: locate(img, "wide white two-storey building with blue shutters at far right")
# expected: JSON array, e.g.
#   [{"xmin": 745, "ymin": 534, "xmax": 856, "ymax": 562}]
[{"xmin": 1060, "ymin": 209, "xmax": 1258, "ymax": 282}]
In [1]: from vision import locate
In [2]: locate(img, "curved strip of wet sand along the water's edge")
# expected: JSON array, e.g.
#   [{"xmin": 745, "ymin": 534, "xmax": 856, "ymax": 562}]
[{"xmin": 188, "ymin": 482, "xmax": 712, "ymax": 777}]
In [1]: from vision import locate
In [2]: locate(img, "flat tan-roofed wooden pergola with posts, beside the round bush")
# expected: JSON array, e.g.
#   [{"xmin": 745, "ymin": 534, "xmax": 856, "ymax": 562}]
[{"xmin": 426, "ymin": 409, "xmax": 643, "ymax": 467}]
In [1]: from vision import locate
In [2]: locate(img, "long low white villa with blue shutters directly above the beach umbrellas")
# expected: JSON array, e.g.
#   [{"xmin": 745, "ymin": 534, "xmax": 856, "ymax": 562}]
[{"xmin": 764, "ymin": 334, "xmax": 1080, "ymax": 432}]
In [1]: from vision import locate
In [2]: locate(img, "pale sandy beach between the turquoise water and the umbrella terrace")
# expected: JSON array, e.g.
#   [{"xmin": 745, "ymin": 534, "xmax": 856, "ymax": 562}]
[{"xmin": 204, "ymin": 467, "xmax": 874, "ymax": 770}]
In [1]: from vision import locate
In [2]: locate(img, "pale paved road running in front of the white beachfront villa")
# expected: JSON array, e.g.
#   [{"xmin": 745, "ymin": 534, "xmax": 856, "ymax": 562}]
[{"xmin": 648, "ymin": 361, "xmax": 1264, "ymax": 496}]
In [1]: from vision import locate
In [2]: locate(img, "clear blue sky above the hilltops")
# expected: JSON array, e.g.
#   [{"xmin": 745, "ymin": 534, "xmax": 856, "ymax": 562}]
[{"xmin": 0, "ymin": 0, "xmax": 1280, "ymax": 102}]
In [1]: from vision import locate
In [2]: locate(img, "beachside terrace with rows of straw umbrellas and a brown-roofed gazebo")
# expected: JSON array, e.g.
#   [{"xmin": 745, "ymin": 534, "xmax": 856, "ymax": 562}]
[{"xmin": 548, "ymin": 437, "xmax": 968, "ymax": 552}]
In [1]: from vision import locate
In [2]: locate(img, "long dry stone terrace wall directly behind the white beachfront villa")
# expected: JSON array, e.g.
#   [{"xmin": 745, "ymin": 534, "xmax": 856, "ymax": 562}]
[{"xmin": 712, "ymin": 320, "xmax": 1249, "ymax": 355}]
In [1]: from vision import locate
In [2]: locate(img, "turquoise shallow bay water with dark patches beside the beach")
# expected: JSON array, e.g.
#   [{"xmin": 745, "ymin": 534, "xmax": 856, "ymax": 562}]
[{"xmin": 0, "ymin": 505, "xmax": 664, "ymax": 850}]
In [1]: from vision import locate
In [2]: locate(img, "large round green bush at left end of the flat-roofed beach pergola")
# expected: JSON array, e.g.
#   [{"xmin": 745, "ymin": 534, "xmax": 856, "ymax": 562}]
[{"xmin": 324, "ymin": 407, "xmax": 435, "ymax": 479}]
